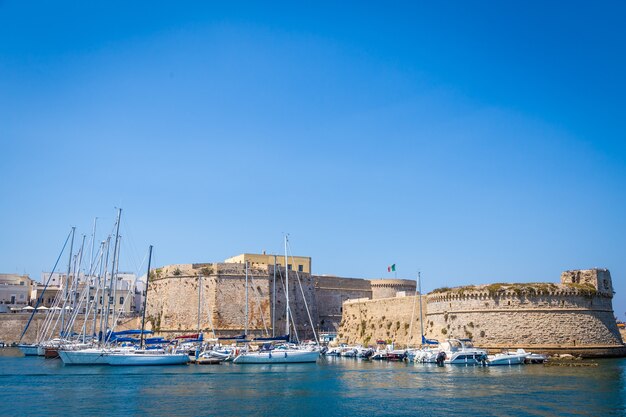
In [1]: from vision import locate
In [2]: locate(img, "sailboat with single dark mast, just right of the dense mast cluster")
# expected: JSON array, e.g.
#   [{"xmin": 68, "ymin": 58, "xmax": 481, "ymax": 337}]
[{"xmin": 105, "ymin": 245, "xmax": 189, "ymax": 366}]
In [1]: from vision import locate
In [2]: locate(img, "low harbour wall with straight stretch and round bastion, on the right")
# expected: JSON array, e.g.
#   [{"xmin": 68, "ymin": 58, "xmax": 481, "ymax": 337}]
[{"xmin": 339, "ymin": 269, "xmax": 626, "ymax": 356}]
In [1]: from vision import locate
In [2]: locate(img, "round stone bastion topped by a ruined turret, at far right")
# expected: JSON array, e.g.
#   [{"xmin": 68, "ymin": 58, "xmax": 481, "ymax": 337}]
[{"xmin": 426, "ymin": 269, "xmax": 623, "ymax": 350}]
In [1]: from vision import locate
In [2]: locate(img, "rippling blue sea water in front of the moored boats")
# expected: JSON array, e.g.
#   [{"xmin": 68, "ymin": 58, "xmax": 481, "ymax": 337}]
[{"xmin": 0, "ymin": 349, "xmax": 626, "ymax": 417}]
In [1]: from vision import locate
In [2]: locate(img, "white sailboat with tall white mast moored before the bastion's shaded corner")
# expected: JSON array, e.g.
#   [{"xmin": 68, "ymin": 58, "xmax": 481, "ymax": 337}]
[{"xmin": 233, "ymin": 236, "xmax": 320, "ymax": 364}]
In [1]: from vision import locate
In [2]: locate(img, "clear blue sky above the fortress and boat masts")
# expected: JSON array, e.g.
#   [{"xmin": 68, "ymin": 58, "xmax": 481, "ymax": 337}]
[{"xmin": 0, "ymin": 1, "xmax": 626, "ymax": 318}]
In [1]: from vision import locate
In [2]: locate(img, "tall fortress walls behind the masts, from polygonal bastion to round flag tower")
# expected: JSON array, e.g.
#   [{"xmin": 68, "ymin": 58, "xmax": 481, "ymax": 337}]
[{"xmin": 146, "ymin": 263, "xmax": 415, "ymax": 339}]
